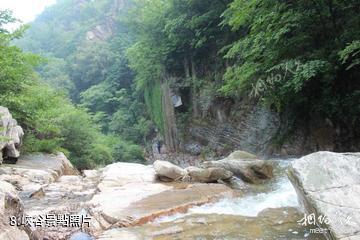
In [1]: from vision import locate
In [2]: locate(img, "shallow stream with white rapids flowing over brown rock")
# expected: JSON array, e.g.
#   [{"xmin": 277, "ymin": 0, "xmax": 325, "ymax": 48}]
[{"xmin": 144, "ymin": 160, "xmax": 325, "ymax": 240}]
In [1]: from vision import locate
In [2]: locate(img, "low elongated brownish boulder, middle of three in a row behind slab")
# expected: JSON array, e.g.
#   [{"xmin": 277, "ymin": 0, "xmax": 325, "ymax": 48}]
[{"xmin": 185, "ymin": 167, "xmax": 233, "ymax": 183}]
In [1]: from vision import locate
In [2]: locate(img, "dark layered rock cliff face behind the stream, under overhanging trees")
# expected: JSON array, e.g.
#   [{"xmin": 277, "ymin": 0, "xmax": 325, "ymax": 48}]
[{"xmin": 165, "ymin": 91, "xmax": 360, "ymax": 156}]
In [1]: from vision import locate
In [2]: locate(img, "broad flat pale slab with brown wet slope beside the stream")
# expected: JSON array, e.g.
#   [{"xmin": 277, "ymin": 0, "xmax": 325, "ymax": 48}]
[{"xmin": 88, "ymin": 162, "xmax": 233, "ymax": 235}]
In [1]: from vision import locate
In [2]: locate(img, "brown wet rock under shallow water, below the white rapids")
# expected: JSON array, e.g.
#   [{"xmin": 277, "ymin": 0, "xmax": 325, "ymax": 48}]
[{"xmin": 99, "ymin": 208, "xmax": 324, "ymax": 240}]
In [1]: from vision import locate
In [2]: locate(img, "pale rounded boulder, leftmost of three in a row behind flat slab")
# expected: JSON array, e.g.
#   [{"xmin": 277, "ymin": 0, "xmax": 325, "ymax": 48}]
[{"xmin": 153, "ymin": 160, "xmax": 186, "ymax": 181}]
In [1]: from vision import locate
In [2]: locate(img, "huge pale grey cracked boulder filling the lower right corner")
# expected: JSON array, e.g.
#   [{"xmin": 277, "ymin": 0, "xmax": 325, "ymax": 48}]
[{"xmin": 288, "ymin": 152, "xmax": 360, "ymax": 240}]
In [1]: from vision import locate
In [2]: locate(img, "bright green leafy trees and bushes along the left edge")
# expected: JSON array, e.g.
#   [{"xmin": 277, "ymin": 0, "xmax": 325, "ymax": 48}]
[{"xmin": 0, "ymin": 11, "xmax": 116, "ymax": 168}]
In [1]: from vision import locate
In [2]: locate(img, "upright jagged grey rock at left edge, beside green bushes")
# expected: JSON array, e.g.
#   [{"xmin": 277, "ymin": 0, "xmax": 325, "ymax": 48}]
[{"xmin": 0, "ymin": 106, "xmax": 24, "ymax": 164}]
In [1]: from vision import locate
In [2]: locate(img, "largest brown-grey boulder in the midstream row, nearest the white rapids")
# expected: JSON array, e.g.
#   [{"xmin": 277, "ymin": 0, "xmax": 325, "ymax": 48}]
[{"xmin": 201, "ymin": 151, "xmax": 273, "ymax": 183}]
